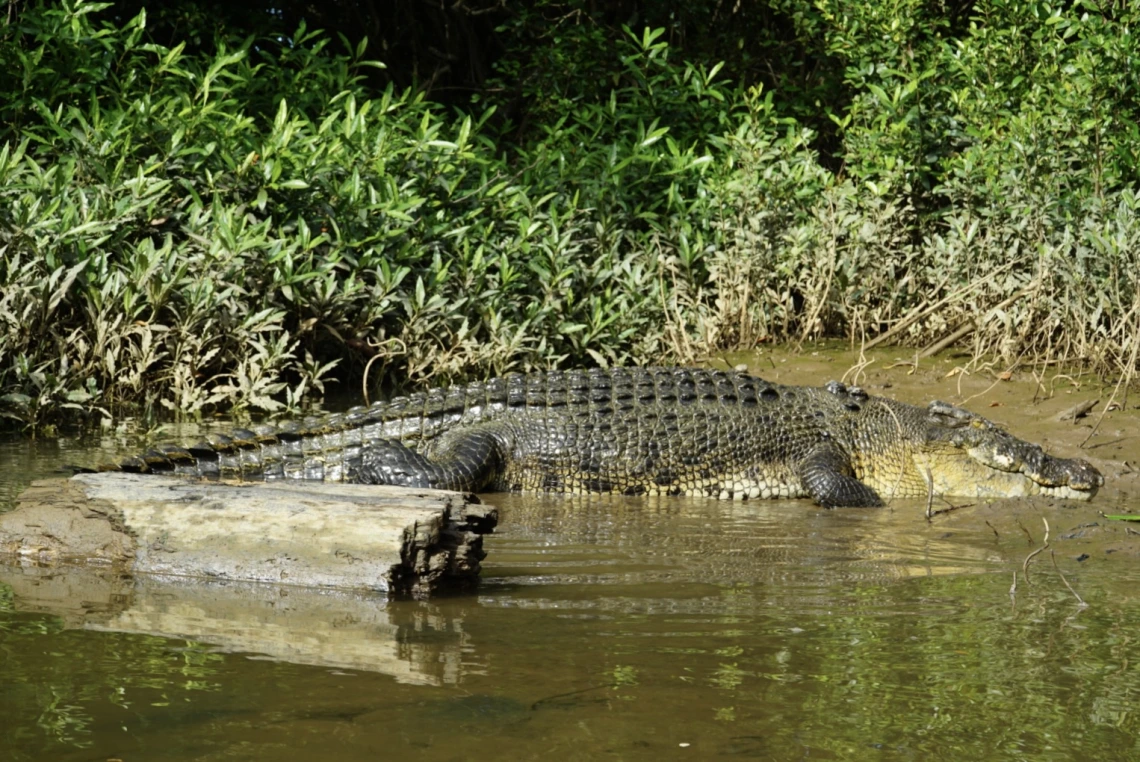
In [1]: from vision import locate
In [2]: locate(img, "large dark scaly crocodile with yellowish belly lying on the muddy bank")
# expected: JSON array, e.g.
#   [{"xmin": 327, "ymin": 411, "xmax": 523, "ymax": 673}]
[{"xmin": 103, "ymin": 367, "xmax": 1104, "ymax": 508}]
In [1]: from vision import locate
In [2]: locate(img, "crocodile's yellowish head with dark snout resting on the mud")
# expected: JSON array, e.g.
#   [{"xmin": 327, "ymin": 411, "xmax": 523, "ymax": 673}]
[{"xmin": 914, "ymin": 402, "xmax": 1105, "ymax": 500}]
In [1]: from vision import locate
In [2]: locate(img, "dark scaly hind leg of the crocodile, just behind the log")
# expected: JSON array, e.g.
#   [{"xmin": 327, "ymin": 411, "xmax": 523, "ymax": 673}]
[{"xmin": 350, "ymin": 430, "xmax": 504, "ymax": 492}]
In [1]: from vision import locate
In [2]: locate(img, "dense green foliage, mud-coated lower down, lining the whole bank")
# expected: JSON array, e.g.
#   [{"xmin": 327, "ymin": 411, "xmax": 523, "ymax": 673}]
[{"xmin": 0, "ymin": 0, "xmax": 1140, "ymax": 427}]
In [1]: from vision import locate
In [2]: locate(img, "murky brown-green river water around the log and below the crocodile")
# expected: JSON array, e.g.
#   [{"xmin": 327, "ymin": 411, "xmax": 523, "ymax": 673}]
[{"xmin": 0, "ymin": 358, "xmax": 1140, "ymax": 762}]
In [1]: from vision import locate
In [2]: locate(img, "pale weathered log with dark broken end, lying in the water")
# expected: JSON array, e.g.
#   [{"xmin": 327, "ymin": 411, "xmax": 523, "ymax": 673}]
[{"xmin": 0, "ymin": 473, "xmax": 498, "ymax": 598}]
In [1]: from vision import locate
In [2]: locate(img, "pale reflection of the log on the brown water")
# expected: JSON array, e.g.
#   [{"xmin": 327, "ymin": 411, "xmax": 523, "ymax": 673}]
[{"xmin": 0, "ymin": 567, "xmax": 470, "ymax": 686}]
